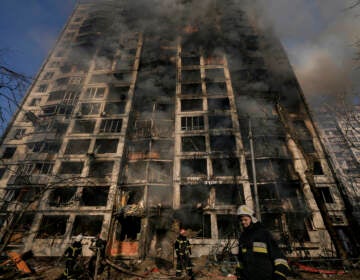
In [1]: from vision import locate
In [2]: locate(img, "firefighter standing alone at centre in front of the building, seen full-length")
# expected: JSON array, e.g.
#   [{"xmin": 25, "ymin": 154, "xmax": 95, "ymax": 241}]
[{"xmin": 175, "ymin": 229, "xmax": 194, "ymax": 279}]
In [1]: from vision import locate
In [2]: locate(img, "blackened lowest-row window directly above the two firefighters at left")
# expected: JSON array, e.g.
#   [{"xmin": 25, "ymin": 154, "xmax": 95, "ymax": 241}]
[{"xmin": 71, "ymin": 215, "xmax": 104, "ymax": 236}]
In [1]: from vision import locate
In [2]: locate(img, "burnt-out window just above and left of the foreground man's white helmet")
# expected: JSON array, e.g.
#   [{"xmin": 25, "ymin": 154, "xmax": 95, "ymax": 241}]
[{"xmin": 212, "ymin": 184, "xmax": 245, "ymax": 205}]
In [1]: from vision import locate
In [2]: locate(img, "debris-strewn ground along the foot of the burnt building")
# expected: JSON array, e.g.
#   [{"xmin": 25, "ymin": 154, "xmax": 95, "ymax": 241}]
[{"xmin": 0, "ymin": 257, "xmax": 360, "ymax": 280}]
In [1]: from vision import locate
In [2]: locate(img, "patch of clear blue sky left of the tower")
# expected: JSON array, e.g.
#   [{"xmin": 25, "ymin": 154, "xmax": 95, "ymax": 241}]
[{"xmin": 0, "ymin": 0, "xmax": 76, "ymax": 77}]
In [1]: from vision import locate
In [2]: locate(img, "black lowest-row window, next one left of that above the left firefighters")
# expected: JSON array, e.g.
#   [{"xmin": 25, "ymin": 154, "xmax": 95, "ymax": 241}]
[{"xmin": 36, "ymin": 215, "xmax": 69, "ymax": 239}]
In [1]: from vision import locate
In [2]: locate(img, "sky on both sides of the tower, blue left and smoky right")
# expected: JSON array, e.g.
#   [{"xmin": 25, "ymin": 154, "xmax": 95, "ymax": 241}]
[{"xmin": 0, "ymin": 0, "xmax": 360, "ymax": 108}]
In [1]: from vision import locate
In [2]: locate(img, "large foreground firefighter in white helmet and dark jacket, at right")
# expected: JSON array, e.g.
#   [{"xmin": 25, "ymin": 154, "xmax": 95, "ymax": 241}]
[{"xmin": 236, "ymin": 205, "xmax": 289, "ymax": 280}]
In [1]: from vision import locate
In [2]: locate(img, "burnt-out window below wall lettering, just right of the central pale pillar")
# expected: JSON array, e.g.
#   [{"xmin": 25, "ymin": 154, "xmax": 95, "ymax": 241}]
[{"xmin": 180, "ymin": 185, "xmax": 210, "ymax": 208}]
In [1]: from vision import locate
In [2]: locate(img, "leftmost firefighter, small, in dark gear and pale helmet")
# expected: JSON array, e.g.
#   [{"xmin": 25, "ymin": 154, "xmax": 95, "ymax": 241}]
[{"xmin": 61, "ymin": 234, "xmax": 83, "ymax": 279}]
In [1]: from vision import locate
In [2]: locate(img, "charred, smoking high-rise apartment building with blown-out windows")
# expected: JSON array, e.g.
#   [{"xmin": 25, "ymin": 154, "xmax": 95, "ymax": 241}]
[{"xmin": 0, "ymin": 0, "xmax": 356, "ymax": 260}]
